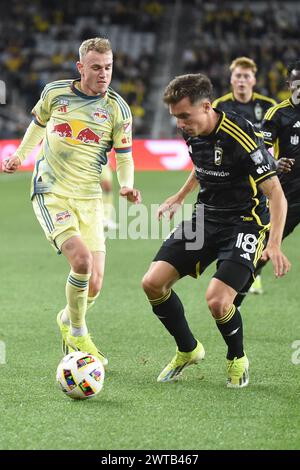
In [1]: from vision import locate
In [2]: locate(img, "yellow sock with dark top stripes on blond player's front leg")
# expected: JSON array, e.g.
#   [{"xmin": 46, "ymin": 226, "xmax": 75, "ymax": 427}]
[{"xmin": 66, "ymin": 271, "xmax": 91, "ymax": 328}]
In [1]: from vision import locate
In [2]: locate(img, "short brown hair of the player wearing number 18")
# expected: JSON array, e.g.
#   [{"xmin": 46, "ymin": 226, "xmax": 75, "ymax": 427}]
[{"xmin": 163, "ymin": 73, "xmax": 213, "ymax": 104}]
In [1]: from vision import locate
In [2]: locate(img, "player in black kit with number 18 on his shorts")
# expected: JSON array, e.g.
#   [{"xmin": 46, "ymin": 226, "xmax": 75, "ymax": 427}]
[{"xmin": 143, "ymin": 74, "xmax": 290, "ymax": 388}]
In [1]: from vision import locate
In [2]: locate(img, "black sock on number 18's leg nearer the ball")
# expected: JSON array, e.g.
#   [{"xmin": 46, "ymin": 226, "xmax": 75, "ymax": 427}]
[{"xmin": 150, "ymin": 289, "xmax": 197, "ymax": 352}]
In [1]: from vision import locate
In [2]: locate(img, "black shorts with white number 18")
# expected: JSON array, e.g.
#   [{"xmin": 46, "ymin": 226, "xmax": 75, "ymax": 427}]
[{"xmin": 153, "ymin": 216, "xmax": 268, "ymax": 277}]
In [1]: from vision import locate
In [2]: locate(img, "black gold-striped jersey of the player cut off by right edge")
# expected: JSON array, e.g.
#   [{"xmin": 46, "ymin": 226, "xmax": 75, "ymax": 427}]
[{"xmin": 262, "ymin": 99, "xmax": 300, "ymax": 204}]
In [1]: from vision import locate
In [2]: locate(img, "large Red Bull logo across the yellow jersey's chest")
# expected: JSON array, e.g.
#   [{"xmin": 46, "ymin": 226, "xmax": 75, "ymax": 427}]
[{"xmin": 51, "ymin": 121, "xmax": 103, "ymax": 145}]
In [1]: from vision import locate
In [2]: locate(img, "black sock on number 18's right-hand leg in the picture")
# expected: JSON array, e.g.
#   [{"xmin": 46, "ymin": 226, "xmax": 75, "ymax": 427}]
[{"xmin": 216, "ymin": 305, "xmax": 244, "ymax": 360}]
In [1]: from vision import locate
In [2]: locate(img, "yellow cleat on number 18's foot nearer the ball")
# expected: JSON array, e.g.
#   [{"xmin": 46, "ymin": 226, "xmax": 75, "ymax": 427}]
[{"xmin": 157, "ymin": 341, "xmax": 205, "ymax": 382}]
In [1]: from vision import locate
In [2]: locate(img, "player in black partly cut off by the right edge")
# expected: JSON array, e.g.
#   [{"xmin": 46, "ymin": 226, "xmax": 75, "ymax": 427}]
[{"xmin": 235, "ymin": 60, "xmax": 300, "ymax": 305}]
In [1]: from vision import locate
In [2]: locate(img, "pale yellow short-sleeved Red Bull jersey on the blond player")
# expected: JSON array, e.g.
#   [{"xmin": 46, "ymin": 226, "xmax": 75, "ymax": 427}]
[{"xmin": 31, "ymin": 79, "xmax": 132, "ymax": 199}]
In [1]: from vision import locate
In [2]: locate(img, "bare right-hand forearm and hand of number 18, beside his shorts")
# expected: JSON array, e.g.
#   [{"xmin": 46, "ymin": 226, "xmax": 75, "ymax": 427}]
[{"xmin": 259, "ymin": 176, "xmax": 291, "ymax": 277}]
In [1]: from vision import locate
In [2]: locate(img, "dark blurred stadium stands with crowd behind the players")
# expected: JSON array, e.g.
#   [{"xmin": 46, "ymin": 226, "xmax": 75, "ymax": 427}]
[{"xmin": 0, "ymin": 0, "xmax": 300, "ymax": 139}]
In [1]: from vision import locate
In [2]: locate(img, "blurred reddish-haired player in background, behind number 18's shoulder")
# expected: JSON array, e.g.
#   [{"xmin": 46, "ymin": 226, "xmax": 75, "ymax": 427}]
[{"xmin": 213, "ymin": 57, "xmax": 276, "ymax": 294}]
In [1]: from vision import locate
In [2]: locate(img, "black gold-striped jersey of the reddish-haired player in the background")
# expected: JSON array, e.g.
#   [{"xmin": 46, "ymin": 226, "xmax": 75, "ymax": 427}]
[{"xmin": 213, "ymin": 93, "xmax": 276, "ymax": 129}]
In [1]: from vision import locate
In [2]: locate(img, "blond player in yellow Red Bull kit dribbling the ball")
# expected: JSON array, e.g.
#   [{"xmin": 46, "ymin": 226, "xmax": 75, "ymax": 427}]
[{"xmin": 3, "ymin": 38, "xmax": 141, "ymax": 365}]
